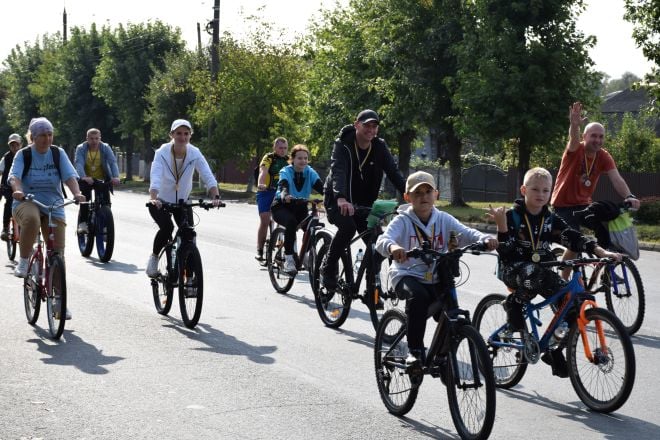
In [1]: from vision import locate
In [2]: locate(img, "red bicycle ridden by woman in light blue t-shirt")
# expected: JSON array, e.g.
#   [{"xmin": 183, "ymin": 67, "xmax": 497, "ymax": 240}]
[{"xmin": 23, "ymin": 194, "xmax": 76, "ymax": 339}]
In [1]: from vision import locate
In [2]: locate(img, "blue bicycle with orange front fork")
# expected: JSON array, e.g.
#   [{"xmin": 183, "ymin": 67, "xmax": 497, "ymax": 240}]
[{"xmin": 474, "ymin": 258, "xmax": 635, "ymax": 413}]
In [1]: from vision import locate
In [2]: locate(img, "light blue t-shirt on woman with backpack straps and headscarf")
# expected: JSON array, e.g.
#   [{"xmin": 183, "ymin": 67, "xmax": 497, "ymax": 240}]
[{"xmin": 9, "ymin": 145, "xmax": 78, "ymax": 220}]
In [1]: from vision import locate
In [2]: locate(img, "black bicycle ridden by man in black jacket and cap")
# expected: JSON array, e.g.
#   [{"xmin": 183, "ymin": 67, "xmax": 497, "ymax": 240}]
[{"xmin": 314, "ymin": 200, "xmax": 399, "ymax": 329}]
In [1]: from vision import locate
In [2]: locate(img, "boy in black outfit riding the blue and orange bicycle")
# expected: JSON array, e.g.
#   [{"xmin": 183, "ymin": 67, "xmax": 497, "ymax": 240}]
[{"xmin": 487, "ymin": 168, "xmax": 621, "ymax": 377}]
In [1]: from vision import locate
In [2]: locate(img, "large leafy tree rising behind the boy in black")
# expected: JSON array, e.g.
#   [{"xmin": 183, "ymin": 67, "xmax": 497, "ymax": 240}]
[{"xmin": 453, "ymin": 0, "xmax": 600, "ymax": 185}]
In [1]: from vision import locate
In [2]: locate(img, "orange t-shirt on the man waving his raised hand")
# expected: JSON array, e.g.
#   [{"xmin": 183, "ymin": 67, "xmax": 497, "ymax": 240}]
[{"xmin": 550, "ymin": 142, "xmax": 616, "ymax": 208}]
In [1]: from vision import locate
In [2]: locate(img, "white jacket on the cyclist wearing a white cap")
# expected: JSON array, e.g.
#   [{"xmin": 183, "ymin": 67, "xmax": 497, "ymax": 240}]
[{"xmin": 149, "ymin": 142, "xmax": 218, "ymax": 203}]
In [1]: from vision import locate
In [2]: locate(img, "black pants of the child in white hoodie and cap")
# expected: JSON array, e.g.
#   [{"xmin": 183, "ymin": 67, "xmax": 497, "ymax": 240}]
[{"xmin": 396, "ymin": 276, "xmax": 438, "ymax": 350}]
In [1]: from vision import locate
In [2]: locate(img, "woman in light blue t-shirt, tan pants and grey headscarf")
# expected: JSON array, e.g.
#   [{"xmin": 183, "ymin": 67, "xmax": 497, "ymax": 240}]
[{"xmin": 8, "ymin": 117, "xmax": 85, "ymax": 298}]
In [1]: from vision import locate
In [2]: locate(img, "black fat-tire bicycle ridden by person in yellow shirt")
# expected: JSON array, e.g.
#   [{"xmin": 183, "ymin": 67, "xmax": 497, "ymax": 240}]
[{"xmin": 77, "ymin": 179, "xmax": 115, "ymax": 263}]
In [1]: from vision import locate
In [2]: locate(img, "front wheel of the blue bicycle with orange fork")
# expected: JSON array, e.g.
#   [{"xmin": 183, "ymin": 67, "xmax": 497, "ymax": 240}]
[{"xmin": 566, "ymin": 308, "xmax": 635, "ymax": 413}]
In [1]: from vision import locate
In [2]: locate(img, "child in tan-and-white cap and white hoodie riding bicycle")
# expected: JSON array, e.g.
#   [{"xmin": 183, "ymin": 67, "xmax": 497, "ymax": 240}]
[{"xmin": 376, "ymin": 171, "xmax": 498, "ymax": 365}]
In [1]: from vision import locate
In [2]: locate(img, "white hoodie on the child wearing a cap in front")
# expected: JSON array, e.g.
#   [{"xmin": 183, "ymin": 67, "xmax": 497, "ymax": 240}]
[{"xmin": 376, "ymin": 205, "xmax": 490, "ymax": 287}]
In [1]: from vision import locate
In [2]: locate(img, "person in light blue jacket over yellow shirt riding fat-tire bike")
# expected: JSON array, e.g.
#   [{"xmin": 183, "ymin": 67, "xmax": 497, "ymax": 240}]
[{"xmin": 74, "ymin": 128, "xmax": 119, "ymax": 234}]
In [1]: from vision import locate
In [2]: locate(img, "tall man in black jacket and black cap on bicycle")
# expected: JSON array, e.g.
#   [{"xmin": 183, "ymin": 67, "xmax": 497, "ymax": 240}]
[{"xmin": 321, "ymin": 109, "xmax": 406, "ymax": 290}]
